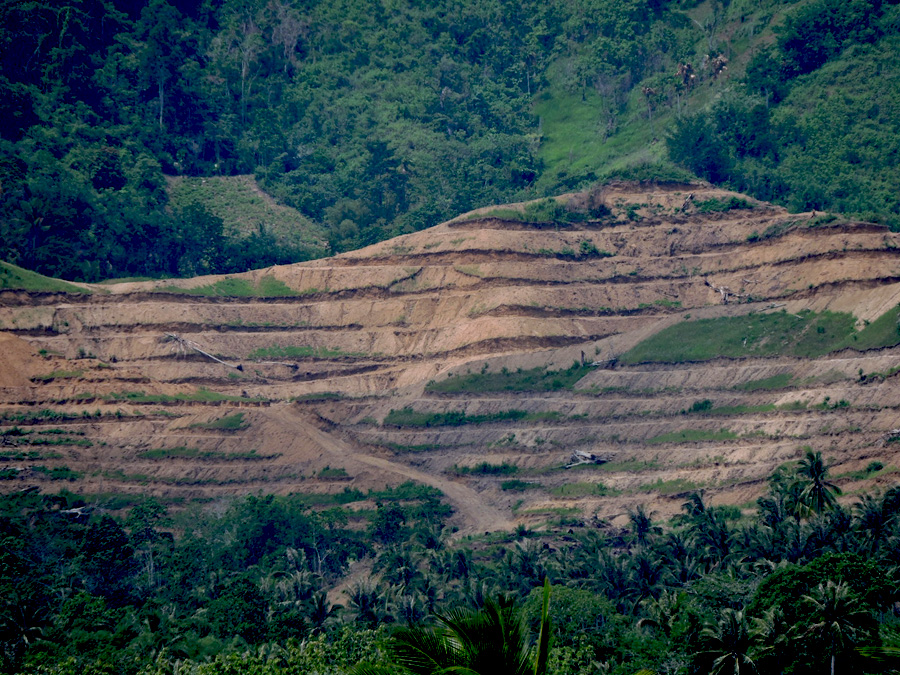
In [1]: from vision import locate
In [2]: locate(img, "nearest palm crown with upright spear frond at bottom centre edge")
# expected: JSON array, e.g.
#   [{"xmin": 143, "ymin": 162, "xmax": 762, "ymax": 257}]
[{"xmin": 352, "ymin": 580, "xmax": 551, "ymax": 675}]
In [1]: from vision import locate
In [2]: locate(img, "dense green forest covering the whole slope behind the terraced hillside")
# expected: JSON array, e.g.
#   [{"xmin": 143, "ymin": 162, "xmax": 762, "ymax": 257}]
[{"xmin": 0, "ymin": 0, "xmax": 900, "ymax": 281}]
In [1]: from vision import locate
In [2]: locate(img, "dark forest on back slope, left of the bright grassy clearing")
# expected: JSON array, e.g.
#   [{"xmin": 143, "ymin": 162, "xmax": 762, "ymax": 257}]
[{"xmin": 0, "ymin": 0, "xmax": 687, "ymax": 280}]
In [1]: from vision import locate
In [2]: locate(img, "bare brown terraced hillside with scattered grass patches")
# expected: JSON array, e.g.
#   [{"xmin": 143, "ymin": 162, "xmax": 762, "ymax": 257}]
[{"xmin": 0, "ymin": 184, "xmax": 900, "ymax": 531}]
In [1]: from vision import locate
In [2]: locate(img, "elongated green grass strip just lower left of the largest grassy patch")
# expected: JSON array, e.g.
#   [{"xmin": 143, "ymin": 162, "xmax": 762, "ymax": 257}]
[{"xmin": 425, "ymin": 362, "xmax": 594, "ymax": 394}]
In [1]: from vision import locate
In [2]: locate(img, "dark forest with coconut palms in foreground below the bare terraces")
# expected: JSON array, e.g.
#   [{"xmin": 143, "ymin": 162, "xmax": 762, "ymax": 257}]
[{"xmin": 0, "ymin": 450, "xmax": 900, "ymax": 675}]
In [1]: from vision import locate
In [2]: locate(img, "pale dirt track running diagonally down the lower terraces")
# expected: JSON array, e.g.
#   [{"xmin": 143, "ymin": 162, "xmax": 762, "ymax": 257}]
[{"xmin": 272, "ymin": 406, "xmax": 514, "ymax": 536}]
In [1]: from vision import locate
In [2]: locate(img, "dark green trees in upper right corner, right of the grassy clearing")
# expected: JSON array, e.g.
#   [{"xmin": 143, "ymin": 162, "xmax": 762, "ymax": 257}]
[{"xmin": 667, "ymin": 0, "xmax": 900, "ymax": 229}]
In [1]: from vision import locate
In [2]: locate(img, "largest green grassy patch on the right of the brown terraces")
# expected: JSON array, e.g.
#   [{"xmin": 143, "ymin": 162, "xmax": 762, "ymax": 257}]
[{"xmin": 619, "ymin": 310, "xmax": 856, "ymax": 363}]
